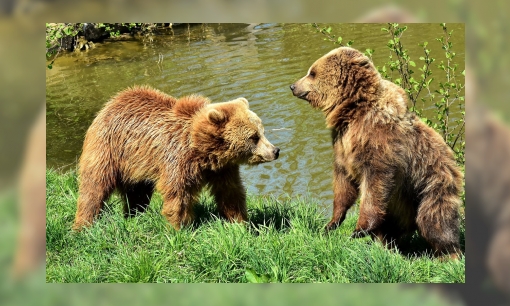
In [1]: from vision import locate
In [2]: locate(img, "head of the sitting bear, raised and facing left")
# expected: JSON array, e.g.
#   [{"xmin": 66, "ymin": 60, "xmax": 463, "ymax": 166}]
[{"xmin": 290, "ymin": 47, "xmax": 381, "ymax": 111}]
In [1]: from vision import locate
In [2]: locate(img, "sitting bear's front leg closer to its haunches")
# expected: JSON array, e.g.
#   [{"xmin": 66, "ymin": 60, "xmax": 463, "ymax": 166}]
[{"xmin": 352, "ymin": 167, "xmax": 393, "ymax": 238}]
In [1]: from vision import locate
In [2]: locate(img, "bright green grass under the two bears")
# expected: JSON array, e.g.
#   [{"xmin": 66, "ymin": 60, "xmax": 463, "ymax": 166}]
[{"xmin": 46, "ymin": 170, "xmax": 465, "ymax": 283}]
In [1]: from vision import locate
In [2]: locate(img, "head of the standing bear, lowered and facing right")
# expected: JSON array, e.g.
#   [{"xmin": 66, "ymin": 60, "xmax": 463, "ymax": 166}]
[{"xmin": 191, "ymin": 98, "xmax": 280, "ymax": 168}]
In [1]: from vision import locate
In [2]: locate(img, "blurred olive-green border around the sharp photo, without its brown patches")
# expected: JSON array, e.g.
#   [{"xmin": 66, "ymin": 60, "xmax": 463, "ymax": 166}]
[{"xmin": 0, "ymin": 0, "xmax": 510, "ymax": 305}]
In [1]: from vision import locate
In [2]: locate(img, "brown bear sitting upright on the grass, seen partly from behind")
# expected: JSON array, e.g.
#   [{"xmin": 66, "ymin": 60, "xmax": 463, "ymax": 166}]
[{"xmin": 290, "ymin": 47, "xmax": 463, "ymax": 258}]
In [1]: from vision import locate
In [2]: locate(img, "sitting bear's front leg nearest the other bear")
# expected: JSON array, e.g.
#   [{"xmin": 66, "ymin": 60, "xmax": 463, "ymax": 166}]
[{"xmin": 326, "ymin": 164, "xmax": 359, "ymax": 231}]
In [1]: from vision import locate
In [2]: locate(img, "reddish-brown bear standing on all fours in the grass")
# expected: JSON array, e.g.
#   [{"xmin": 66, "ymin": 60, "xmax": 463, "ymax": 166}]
[{"xmin": 73, "ymin": 86, "xmax": 280, "ymax": 230}]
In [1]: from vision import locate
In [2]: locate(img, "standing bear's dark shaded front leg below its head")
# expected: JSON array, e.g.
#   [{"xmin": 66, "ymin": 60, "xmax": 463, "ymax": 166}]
[{"xmin": 209, "ymin": 166, "xmax": 248, "ymax": 222}]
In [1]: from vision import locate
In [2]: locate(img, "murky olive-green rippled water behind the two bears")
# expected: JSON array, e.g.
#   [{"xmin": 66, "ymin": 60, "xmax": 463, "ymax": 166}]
[{"xmin": 46, "ymin": 24, "xmax": 464, "ymax": 205}]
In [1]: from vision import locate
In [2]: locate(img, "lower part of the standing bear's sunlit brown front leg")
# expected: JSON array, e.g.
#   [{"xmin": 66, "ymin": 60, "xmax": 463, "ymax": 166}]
[{"xmin": 161, "ymin": 196, "xmax": 193, "ymax": 230}]
